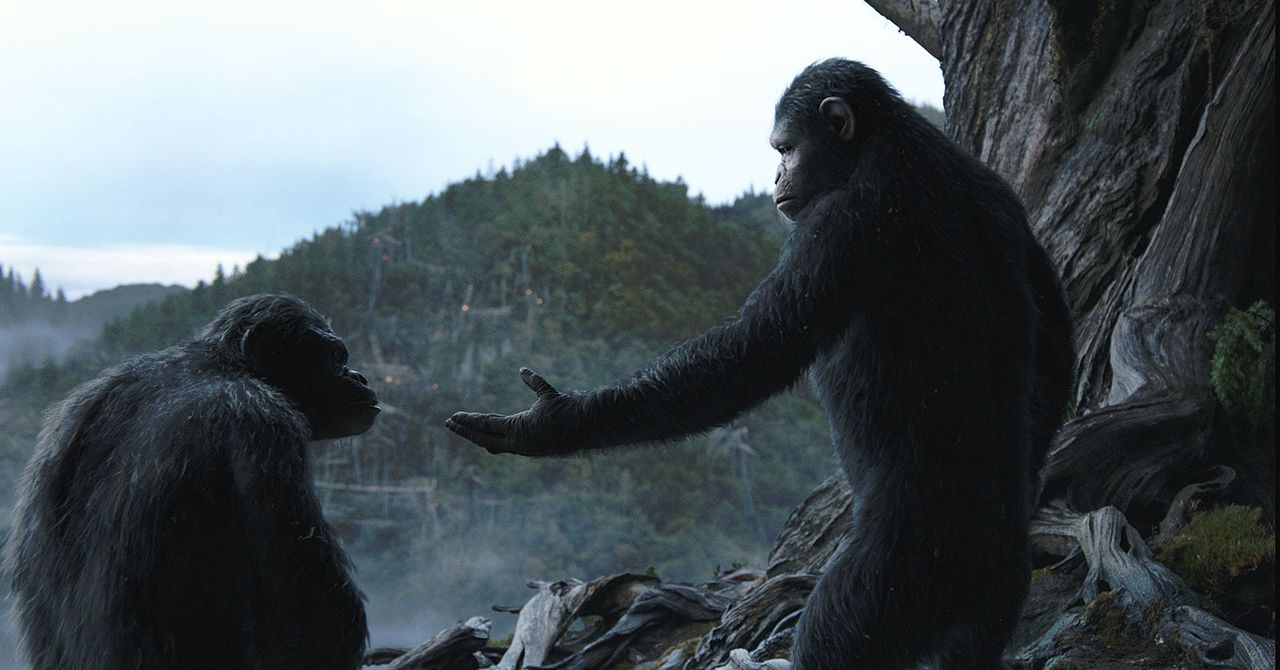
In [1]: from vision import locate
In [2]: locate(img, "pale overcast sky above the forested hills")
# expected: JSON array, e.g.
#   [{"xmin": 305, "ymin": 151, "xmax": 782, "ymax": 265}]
[{"xmin": 0, "ymin": 0, "xmax": 942, "ymax": 297}]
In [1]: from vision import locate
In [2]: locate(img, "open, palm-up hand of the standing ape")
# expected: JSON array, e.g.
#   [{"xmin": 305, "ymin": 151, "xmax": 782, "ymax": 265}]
[{"xmin": 444, "ymin": 368, "xmax": 577, "ymax": 456}]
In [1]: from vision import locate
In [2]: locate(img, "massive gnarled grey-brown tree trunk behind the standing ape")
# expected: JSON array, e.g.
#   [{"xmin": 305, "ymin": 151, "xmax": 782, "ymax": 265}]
[{"xmin": 868, "ymin": 0, "xmax": 1275, "ymax": 528}]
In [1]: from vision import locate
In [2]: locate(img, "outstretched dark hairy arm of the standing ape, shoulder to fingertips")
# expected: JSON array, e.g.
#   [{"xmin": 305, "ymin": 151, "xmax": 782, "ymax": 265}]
[{"xmin": 447, "ymin": 190, "xmax": 874, "ymax": 456}]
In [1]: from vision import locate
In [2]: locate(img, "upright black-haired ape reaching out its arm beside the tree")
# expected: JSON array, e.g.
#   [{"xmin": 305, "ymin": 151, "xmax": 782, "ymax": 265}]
[{"xmin": 448, "ymin": 59, "xmax": 1074, "ymax": 670}]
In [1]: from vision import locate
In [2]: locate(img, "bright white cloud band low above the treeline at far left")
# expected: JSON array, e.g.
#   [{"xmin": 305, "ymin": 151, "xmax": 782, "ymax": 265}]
[{"xmin": 0, "ymin": 234, "xmax": 270, "ymax": 300}]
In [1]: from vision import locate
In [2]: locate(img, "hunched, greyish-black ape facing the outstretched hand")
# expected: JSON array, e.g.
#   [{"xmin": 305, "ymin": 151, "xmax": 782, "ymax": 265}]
[{"xmin": 8, "ymin": 295, "xmax": 379, "ymax": 670}]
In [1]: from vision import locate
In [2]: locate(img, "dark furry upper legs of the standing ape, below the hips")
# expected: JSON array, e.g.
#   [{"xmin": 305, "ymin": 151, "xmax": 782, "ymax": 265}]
[{"xmin": 791, "ymin": 532, "xmax": 1029, "ymax": 670}]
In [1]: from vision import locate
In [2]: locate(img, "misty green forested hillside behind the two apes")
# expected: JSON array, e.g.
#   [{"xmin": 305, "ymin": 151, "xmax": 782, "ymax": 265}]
[{"xmin": 0, "ymin": 147, "xmax": 833, "ymax": 642}]
